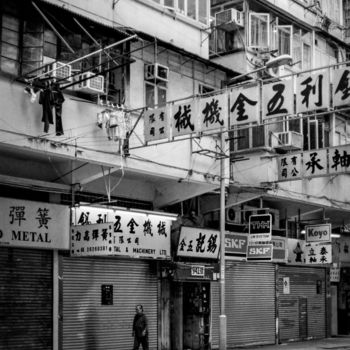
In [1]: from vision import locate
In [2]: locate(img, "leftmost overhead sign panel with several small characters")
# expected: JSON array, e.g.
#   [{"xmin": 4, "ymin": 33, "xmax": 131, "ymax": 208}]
[{"xmin": 144, "ymin": 107, "xmax": 169, "ymax": 142}]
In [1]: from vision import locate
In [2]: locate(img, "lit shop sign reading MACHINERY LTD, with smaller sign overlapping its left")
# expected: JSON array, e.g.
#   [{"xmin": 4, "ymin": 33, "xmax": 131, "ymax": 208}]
[{"xmin": 71, "ymin": 207, "xmax": 172, "ymax": 259}]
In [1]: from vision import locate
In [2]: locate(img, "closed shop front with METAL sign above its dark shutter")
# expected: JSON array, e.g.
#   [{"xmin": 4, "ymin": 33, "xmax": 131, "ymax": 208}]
[{"xmin": 0, "ymin": 198, "xmax": 69, "ymax": 350}]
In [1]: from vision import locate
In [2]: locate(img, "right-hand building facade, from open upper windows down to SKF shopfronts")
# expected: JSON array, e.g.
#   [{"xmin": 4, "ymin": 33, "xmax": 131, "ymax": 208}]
[{"xmin": 204, "ymin": 0, "xmax": 349, "ymax": 345}]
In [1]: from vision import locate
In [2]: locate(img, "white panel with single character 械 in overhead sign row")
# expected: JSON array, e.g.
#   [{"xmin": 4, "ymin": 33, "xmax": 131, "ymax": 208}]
[{"xmin": 171, "ymin": 100, "xmax": 198, "ymax": 137}]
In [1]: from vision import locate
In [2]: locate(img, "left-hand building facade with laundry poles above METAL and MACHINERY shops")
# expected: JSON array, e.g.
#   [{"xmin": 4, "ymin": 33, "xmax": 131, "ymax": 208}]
[{"xmin": 0, "ymin": 0, "xmax": 237, "ymax": 350}]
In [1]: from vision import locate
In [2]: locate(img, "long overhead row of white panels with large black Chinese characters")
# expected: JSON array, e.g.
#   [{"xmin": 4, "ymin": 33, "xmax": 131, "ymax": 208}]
[{"xmin": 144, "ymin": 68, "xmax": 350, "ymax": 142}]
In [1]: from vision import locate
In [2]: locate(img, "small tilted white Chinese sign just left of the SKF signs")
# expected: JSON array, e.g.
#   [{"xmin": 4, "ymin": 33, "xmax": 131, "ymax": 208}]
[{"xmin": 177, "ymin": 226, "xmax": 220, "ymax": 259}]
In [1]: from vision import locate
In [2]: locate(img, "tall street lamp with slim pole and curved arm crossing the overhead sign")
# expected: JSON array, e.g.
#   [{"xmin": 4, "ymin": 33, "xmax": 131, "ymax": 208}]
[{"xmin": 219, "ymin": 55, "xmax": 293, "ymax": 350}]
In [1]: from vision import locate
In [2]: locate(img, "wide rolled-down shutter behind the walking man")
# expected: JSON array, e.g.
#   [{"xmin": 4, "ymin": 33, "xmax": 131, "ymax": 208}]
[{"xmin": 61, "ymin": 257, "xmax": 158, "ymax": 350}]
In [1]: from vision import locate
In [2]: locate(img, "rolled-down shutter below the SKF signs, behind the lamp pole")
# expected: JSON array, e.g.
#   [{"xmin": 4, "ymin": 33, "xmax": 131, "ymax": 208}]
[{"xmin": 212, "ymin": 261, "xmax": 276, "ymax": 347}]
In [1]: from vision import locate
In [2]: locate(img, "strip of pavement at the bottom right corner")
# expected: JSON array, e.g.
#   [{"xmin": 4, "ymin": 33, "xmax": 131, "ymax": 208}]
[{"xmin": 228, "ymin": 335, "xmax": 350, "ymax": 350}]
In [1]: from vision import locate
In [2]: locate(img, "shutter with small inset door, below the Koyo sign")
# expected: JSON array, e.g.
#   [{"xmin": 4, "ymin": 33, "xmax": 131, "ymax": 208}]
[{"xmin": 278, "ymin": 266, "xmax": 326, "ymax": 341}]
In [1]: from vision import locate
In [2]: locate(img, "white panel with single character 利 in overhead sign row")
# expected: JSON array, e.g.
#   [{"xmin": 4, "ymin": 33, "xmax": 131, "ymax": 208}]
[{"xmin": 296, "ymin": 72, "xmax": 329, "ymax": 113}]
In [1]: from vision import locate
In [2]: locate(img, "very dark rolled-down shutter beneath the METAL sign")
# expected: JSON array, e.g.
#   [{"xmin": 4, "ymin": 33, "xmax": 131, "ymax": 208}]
[{"xmin": 0, "ymin": 248, "xmax": 53, "ymax": 350}]
